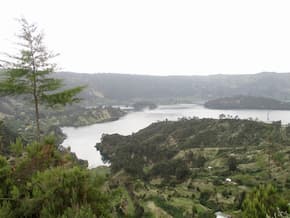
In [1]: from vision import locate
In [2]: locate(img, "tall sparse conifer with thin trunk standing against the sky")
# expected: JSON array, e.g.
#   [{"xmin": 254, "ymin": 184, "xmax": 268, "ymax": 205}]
[{"xmin": 0, "ymin": 18, "xmax": 84, "ymax": 141}]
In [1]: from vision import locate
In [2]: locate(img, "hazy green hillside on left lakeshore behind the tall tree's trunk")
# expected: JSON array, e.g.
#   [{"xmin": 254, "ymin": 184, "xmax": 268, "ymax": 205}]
[{"xmin": 0, "ymin": 97, "xmax": 126, "ymax": 142}]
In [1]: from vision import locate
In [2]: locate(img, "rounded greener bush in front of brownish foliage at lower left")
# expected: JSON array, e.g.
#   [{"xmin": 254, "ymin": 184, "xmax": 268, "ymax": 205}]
[{"xmin": 23, "ymin": 167, "xmax": 109, "ymax": 217}]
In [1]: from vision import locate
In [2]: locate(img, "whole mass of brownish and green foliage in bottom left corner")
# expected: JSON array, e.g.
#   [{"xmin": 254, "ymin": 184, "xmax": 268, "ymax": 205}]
[{"xmin": 0, "ymin": 137, "xmax": 112, "ymax": 218}]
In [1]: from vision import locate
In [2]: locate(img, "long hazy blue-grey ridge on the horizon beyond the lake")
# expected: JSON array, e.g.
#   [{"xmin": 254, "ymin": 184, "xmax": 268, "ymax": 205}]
[{"xmin": 56, "ymin": 72, "xmax": 290, "ymax": 103}]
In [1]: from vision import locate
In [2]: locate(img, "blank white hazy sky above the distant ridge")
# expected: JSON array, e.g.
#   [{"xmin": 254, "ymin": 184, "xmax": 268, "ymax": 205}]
[{"xmin": 0, "ymin": 0, "xmax": 290, "ymax": 75}]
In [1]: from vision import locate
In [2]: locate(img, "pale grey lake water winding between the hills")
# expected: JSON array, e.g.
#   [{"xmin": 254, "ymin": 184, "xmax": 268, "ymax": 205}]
[{"xmin": 62, "ymin": 104, "xmax": 290, "ymax": 168}]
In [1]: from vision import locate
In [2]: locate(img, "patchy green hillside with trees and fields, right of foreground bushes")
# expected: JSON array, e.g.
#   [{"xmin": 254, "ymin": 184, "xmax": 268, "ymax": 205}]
[{"xmin": 96, "ymin": 119, "xmax": 290, "ymax": 217}]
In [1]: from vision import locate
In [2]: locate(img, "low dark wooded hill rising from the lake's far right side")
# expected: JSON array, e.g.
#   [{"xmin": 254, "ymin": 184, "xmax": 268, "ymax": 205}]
[{"xmin": 204, "ymin": 95, "xmax": 290, "ymax": 110}]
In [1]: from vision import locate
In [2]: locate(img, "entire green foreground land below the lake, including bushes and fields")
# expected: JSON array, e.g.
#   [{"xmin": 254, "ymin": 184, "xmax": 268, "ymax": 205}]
[{"xmin": 0, "ymin": 114, "xmax": 290, "ymax": 218}]
